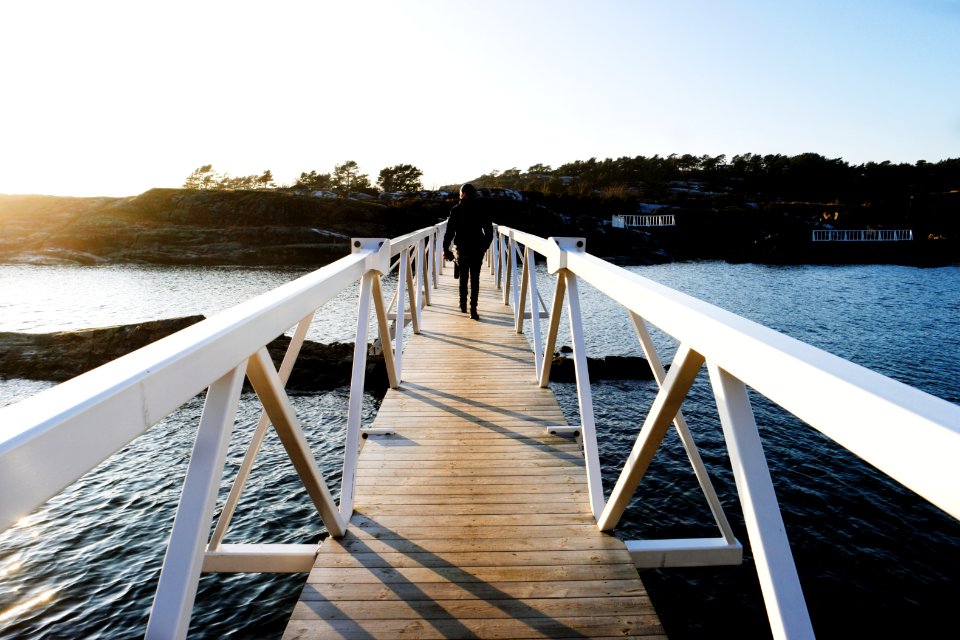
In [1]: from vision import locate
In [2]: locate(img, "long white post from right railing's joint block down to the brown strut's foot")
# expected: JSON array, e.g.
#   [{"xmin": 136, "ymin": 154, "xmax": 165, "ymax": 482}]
[{"xmin": 557, "ymin": 269, "xmax": 603, "ymax": 519}]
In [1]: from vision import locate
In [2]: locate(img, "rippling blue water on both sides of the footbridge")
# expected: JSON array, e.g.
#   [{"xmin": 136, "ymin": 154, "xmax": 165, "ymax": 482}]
[{"xmin": 0, "ymin": 262, "xmax": 960, "ymax": 638}]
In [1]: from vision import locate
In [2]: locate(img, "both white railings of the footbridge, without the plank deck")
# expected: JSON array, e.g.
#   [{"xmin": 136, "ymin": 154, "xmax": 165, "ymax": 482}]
[{"xmin": 0, "ymin": 220, "xmax": 960, "ymax": 638}]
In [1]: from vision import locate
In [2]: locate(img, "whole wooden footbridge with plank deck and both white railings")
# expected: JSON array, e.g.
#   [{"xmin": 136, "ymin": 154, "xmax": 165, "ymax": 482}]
[{"xmin": 0, "ymin": 224, "xmax": 960, "ymax": 640}]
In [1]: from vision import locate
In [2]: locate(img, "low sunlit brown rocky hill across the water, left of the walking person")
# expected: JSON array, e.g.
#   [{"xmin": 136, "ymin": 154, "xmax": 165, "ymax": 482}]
[{"xmin": 0, "ymin": 189, "xmax": 448, "ymax": 266}]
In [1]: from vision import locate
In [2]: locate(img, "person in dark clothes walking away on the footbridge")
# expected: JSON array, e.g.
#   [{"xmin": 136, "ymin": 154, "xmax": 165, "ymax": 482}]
[{"xmin": 443, "ymin": 183, "xmax": 493, "ymax": 320}]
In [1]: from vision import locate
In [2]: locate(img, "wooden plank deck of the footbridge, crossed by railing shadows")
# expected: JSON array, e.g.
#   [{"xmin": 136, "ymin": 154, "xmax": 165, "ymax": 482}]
[{"xmin": 283, "ymin": 262, "xmax": 665, "ymax": 639}]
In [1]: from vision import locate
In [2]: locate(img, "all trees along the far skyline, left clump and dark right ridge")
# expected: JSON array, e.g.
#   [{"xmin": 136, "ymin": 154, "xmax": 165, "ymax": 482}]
[{"xmin": 183, "ymin": 153, "xmax": 960, "ymax": 202}]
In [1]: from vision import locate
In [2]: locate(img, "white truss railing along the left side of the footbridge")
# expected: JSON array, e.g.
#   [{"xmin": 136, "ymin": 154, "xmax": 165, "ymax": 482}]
[{"xmin": 0, "ymin": 223, "xmax": 446, "ymax": 638}]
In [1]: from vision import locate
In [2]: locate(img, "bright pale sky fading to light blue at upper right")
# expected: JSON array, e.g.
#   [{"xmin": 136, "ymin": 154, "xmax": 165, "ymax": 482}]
[{"xmin": 0, "ymin": 0, "xmax": 960, "ymax": 196}]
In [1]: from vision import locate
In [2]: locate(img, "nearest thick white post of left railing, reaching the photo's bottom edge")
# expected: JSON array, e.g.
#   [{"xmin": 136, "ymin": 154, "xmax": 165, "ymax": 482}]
[{"xmin": 146, "ymin": 363, "xmax": 245, "ymax": 640}]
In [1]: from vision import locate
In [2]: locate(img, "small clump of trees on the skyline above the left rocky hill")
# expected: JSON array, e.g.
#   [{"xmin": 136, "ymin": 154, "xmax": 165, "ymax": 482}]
[{"xmin": 183, "ymin": 160, "xmax": 423, "ymax": 198}]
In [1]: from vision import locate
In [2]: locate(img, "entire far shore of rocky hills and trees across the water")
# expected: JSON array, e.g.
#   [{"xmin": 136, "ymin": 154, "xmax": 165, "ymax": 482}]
[{"xmin": 0, "ymin": 154, "xmax": 960, "ymax": 266}]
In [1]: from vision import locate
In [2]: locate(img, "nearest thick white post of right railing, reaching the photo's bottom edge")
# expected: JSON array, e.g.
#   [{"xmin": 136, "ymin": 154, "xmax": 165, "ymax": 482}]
[{"xmin": 707, "ymin": 364, "xmax": 814, "ymax": 638}]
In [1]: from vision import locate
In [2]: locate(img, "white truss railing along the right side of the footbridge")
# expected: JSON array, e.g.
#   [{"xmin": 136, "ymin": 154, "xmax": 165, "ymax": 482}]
[{"xmin": 491, "ymin": 226, "xmax": 960, "ymax": 638}]
